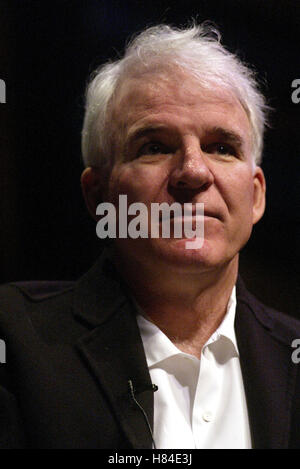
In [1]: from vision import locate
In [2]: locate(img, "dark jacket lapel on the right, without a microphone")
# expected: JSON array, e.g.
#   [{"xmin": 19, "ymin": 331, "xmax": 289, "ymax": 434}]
[{"xmin": 235, "ymin": 282, "xmax": 296, "ymax": 449}]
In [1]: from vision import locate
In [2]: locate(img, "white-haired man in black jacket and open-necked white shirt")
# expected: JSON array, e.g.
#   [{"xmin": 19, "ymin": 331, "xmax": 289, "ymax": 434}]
[{"xmin": 0, "ymin": 25, "xmax": 300, "ymax": 449}]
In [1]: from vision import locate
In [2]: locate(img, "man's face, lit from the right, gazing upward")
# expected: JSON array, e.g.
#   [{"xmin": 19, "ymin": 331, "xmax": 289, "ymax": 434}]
[{"xmin": 100, "ymin": 74, "xmax": 264, "ymax": 271}]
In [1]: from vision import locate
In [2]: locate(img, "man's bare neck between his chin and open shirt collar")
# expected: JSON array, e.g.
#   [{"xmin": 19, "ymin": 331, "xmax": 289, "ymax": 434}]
[{"xmin": 116, "ymin": 247, "xmax": 238, "ymax": 358}]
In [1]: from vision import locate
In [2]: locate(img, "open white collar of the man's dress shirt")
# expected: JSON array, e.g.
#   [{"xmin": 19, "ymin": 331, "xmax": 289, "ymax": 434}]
[{"xmin": 137, "ymin": 286, "xmax": 239, "ymax": 367}]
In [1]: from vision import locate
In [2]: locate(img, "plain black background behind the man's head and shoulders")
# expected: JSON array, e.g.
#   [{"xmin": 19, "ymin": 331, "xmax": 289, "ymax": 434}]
[{"xmin": 0, "ymin": 0, "xmax": 300, "ymax": 317}]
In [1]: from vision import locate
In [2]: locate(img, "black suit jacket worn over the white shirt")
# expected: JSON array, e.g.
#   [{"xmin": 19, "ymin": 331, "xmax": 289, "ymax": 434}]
[{"xmin": 0, "ymin": 250, "xmax": 300, "ymax": 449}]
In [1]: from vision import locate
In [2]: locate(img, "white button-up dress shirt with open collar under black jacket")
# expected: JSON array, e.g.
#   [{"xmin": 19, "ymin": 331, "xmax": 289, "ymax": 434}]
[{"xmin": 137, "ymin": 287, "xmax": 251, "ymax": 449}]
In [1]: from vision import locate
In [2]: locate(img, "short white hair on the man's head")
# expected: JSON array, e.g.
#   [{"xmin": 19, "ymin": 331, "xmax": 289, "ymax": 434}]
[{"xmin": 82, "ymin": 22, "xmax": 268, "ymax": 167}]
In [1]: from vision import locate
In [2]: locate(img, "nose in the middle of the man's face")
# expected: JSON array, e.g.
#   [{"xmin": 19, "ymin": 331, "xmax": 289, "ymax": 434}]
[{"xmin": 169, "ymin": 142, "xmax": 214, "ymax": 191}]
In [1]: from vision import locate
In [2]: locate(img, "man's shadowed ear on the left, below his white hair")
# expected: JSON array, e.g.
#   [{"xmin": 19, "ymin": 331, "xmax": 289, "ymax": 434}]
[{"xmin": 81, "ymin": 167, "xmax": 104, "ymax": 220}]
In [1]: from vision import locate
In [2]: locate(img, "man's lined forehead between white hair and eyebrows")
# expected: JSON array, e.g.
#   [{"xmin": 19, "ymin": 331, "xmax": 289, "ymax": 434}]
[{"xmin": 113, "ymin": 71, "xmax": 251, "ymax": 142}]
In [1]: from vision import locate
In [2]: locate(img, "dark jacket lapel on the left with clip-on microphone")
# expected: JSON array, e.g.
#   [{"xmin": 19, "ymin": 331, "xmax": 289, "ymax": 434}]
[{"xmin": 74, "ymin": 250, "xmax": 153, "ymax": 449}]
